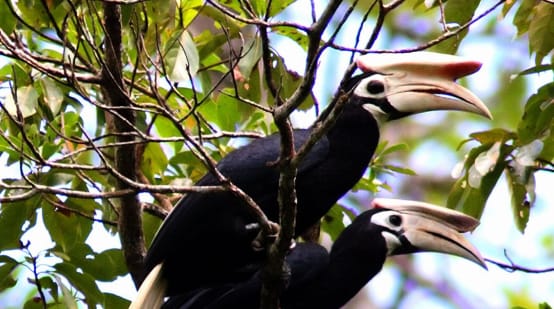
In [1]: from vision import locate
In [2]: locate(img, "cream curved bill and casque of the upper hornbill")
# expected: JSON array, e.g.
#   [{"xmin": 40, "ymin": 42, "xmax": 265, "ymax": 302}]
[{"xmin": 356, "ymin": 52, "xmax": 492, "ymax": 118}]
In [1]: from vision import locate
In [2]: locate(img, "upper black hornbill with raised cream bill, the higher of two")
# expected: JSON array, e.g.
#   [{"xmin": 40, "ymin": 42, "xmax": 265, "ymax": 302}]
[{"xmin": 132, "ymin": 52, "xmax": 490, "ymax": 304}]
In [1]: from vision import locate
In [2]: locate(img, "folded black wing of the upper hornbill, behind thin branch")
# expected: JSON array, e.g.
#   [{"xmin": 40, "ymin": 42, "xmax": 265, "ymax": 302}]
[{"xmin": 141, "ymin": 129, "xmax": 329, "ymax": 287}]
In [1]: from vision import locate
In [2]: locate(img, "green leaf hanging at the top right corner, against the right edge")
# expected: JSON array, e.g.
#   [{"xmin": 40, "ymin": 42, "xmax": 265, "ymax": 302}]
[{"xmin": 529, "ymin": 1, "xmax": 554, "ymax": 65}]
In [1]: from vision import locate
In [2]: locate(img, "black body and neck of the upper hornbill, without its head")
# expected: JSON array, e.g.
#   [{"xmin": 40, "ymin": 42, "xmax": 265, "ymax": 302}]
[{"xmin": 146, "ymin": 101, "xmax": 379, "ymax": 295}]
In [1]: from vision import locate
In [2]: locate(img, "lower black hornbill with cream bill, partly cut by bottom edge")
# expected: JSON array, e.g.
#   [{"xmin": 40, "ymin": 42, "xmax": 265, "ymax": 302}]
[{"xmin": 158, "ymin": 199, "xmax": 486, "ymax": 309}]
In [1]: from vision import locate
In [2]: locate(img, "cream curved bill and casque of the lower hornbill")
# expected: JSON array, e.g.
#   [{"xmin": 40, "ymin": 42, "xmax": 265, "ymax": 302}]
[{"xmin": 373, "ymin": 198, "xmax": 487, "ymax": 269}]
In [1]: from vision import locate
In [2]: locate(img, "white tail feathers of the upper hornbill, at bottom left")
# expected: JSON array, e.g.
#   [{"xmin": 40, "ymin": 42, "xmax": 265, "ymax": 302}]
[{"xmin": 129, "ymin": 263, "xmax": 167, "ymax": 309}]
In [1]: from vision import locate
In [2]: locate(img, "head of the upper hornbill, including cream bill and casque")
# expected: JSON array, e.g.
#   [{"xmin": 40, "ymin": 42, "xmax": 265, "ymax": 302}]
[{"xmin": 346, "ymin": 52, "xmax": 491, "ymax": 121}]
